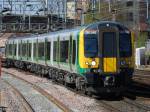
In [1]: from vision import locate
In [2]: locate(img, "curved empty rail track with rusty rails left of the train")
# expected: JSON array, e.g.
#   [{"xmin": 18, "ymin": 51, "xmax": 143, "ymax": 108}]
[{"xmin": 3, "ymin": 71, "xmax": 72, "ymax": 112}]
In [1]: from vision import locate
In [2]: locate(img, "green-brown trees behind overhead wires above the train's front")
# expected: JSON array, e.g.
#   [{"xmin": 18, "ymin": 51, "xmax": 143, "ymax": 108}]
[{"xmin": 84, "ymin": 2, "xmax": 124, "ymax": 24}]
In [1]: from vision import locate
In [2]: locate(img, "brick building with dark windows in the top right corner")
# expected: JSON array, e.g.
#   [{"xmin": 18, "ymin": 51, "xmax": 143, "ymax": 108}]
[{"xmin": 118, "ymin": 0, "xmax": 150, "ymax": 32}]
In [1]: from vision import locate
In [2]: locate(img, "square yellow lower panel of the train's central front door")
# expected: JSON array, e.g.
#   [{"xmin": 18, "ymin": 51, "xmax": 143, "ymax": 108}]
[{"xmin": 103, "ymin": 58, "xmax": 117, "ymax": 73}]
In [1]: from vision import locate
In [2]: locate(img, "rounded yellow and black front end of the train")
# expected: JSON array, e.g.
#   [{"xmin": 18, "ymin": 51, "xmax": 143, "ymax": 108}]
[{"xmin": 79, "ymin": 22, "xmax": 134, "ymax": 93}]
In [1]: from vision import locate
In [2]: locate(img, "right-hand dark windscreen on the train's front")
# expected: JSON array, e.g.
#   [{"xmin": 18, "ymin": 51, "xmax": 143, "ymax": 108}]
[{"xmin": 119, "ymin": 33, "xmax": 132, "ymax": 57}]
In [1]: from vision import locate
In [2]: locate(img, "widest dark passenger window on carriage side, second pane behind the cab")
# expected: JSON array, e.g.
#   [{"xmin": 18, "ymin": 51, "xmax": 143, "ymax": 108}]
[{"xmin": 60, "ymin": 40, "xmax": 69, "ymax": 63}]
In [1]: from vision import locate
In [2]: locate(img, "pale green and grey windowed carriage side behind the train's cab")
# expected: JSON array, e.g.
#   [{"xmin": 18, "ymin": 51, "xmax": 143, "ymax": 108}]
[{"xmin": 6, "ymin": 30, "xmax": 82, "ymax": 73}]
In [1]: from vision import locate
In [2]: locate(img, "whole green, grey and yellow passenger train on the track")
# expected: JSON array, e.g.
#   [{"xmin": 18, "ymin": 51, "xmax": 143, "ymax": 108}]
[{"xmin": 5, "ymin": 21, "xmax": 135, "ymax": 94}]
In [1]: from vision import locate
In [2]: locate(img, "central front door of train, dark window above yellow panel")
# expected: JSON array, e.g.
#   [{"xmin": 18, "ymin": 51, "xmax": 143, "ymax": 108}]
[{"xmin": 99, "ymin": 27, "xmax": 119, "ymax": 74}]
